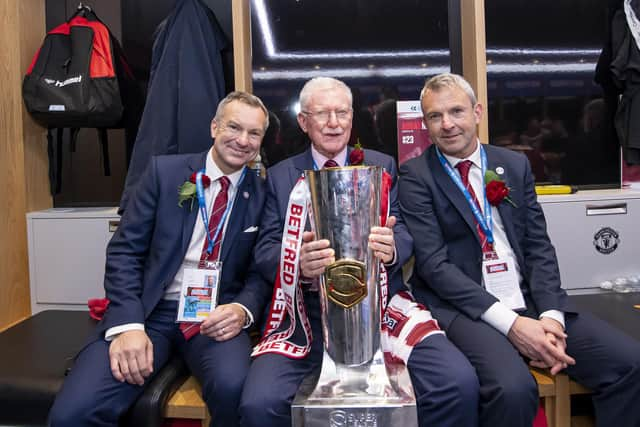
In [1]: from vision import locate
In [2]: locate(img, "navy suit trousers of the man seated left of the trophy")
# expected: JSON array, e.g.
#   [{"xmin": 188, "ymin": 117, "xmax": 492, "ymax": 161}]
[{"xmin": 49, "ymin": 300, "xmax": 250, "ymax": 427}]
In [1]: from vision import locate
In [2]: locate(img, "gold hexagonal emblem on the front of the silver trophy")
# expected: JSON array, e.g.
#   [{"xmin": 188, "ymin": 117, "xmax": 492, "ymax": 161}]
[{"xmin": 325, "ymin": 259, "xmax": 367, "ymax": 308}]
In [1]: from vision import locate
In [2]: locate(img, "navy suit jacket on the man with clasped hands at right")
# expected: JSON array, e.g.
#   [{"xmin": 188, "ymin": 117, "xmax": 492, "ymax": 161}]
[{"xmin": 399, "ymin": 145, "xmax": 569, "ymax": 329}]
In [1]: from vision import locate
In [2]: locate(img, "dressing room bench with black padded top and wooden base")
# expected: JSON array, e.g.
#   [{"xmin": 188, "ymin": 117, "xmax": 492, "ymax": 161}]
[{"xmin": 0, "ymin": 293, "xmax": 640, "ymax": 427}]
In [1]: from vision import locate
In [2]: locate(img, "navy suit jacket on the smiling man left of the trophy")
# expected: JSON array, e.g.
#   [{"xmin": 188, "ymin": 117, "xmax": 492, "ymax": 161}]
[{"xmin": 96, "ymin": 152, "xmax": 264, "ymax": 336}]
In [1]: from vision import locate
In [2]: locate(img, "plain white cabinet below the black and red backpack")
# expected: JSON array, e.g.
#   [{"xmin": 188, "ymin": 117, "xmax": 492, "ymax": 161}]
[{"xmin": 27, "ymin": 208, "xmax": 120, "ymax": 314}]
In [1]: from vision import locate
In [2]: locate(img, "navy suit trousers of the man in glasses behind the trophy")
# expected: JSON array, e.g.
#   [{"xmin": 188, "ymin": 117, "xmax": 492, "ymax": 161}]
[{"xmin": 240, "ymin": 292, "xmax": 479, "ymax": 427}]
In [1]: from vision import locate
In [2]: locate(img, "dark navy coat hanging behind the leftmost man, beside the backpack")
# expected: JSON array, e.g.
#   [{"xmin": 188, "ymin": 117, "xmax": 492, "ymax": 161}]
[{"xmin": 119, "ymin": 0, "xmax": 231, "ymax": 213}]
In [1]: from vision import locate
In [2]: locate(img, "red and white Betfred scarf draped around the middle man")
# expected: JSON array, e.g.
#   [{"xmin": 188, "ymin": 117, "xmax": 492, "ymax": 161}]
[{"xmin": 251, "ymin": 172, "xmax": 443, "ymax": 364}]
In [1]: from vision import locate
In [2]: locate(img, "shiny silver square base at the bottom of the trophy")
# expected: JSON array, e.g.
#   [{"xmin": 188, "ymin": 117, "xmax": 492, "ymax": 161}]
[{"xmin": 291, "ymin": 353, "xmax": 418, "ymax": 427}]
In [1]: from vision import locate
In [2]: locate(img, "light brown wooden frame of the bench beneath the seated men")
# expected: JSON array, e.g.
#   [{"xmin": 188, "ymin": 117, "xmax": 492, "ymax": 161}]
[{"xmin": 164, "ymin": 368, "xmax": 591, "ymax": 427}]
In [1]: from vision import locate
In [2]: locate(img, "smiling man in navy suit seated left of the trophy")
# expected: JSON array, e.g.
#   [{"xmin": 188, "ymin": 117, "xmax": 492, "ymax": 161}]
[{"xmin": 50, "ymin": 92, "xmax": 268, "ymax": 427}]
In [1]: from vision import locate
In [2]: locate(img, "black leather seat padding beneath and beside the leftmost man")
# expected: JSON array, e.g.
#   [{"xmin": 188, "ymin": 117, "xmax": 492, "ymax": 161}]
[{"xmin": 0, "ymin": 310, "xmax": 188, "ymax": 426}]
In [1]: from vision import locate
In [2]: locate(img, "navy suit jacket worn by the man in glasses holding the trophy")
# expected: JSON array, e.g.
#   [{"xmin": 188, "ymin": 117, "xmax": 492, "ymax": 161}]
[{"xmin": 255, "ymin": 148, "xmax": 412, "ymax": 308}]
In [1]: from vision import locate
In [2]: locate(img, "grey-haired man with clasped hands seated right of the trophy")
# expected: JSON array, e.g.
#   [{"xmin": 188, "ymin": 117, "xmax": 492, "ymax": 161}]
[{"xmin": 399, "ymin": 74, "xmax": 640, "ymax": 427}]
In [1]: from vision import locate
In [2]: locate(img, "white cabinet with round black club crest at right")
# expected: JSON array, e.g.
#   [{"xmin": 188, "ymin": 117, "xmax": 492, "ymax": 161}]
[{"xmin": 538, "ymin": 190, "xmax": 640, "ymax": 290}]
